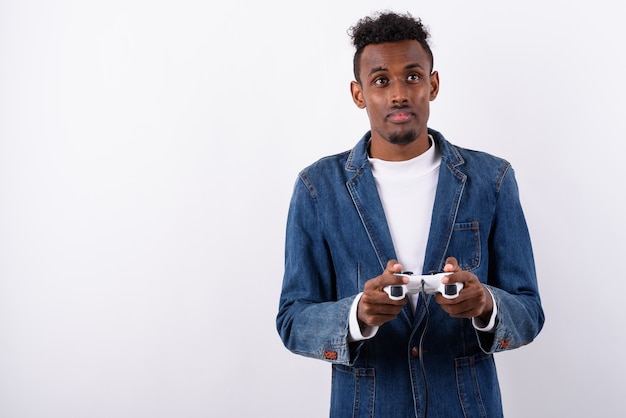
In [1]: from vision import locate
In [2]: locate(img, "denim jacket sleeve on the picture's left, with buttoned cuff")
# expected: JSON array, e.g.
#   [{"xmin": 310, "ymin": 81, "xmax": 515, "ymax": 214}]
[{"xmin": 276, "ymin": 172, "xmax": 362, "ymax": 365}]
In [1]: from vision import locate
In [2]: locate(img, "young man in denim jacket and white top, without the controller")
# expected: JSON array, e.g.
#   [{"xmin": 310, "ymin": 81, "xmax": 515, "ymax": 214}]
[{"xmin": 277, "ymin": 13, "xmax": 544, "ymax": 418}]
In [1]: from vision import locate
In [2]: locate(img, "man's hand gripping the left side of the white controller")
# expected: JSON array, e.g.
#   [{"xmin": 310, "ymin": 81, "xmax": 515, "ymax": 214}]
[{"xmin": 357, "ymin": 260, "xmax": 409, "ymax": 327}]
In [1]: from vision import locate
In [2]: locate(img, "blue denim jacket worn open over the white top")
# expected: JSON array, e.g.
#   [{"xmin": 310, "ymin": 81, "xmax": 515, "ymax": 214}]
[{"xmin": 276, "ymin": 129, "xmax": 544, "ymax": 418}]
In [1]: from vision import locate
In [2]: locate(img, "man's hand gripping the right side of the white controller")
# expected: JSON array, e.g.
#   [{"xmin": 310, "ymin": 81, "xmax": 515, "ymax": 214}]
[{"xmin": 435, "ymin": 257, "xmax": 493, "ymax": 323}]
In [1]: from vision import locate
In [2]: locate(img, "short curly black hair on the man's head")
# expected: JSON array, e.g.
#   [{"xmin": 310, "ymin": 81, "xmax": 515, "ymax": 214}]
[{"xmin": 348, "ymin": 12, "xmax": 434, "ymax": 82}]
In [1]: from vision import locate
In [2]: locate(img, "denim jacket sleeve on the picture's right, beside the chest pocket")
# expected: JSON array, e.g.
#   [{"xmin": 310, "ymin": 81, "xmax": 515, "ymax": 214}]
[{"xmin": 476, "ymin": 166, "xmax": 545, "ymax": 353}]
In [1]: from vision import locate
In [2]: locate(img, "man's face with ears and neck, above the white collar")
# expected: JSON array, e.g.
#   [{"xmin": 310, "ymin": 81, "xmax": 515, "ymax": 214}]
[{"xmin": 351, "ymin": 40, "xmax": 439, "ymax": 158}]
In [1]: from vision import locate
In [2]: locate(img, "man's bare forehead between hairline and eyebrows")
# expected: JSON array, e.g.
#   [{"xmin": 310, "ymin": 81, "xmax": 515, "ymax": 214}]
[{"xmin": 360, "ymin": 40, "xmax": 430, "ymax": 76}]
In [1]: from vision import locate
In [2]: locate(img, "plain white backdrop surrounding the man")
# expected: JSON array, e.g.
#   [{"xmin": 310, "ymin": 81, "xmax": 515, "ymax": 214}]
[{"xmin": 0, "ymin": 0, "xmax": 626, "ymax": 418}]
